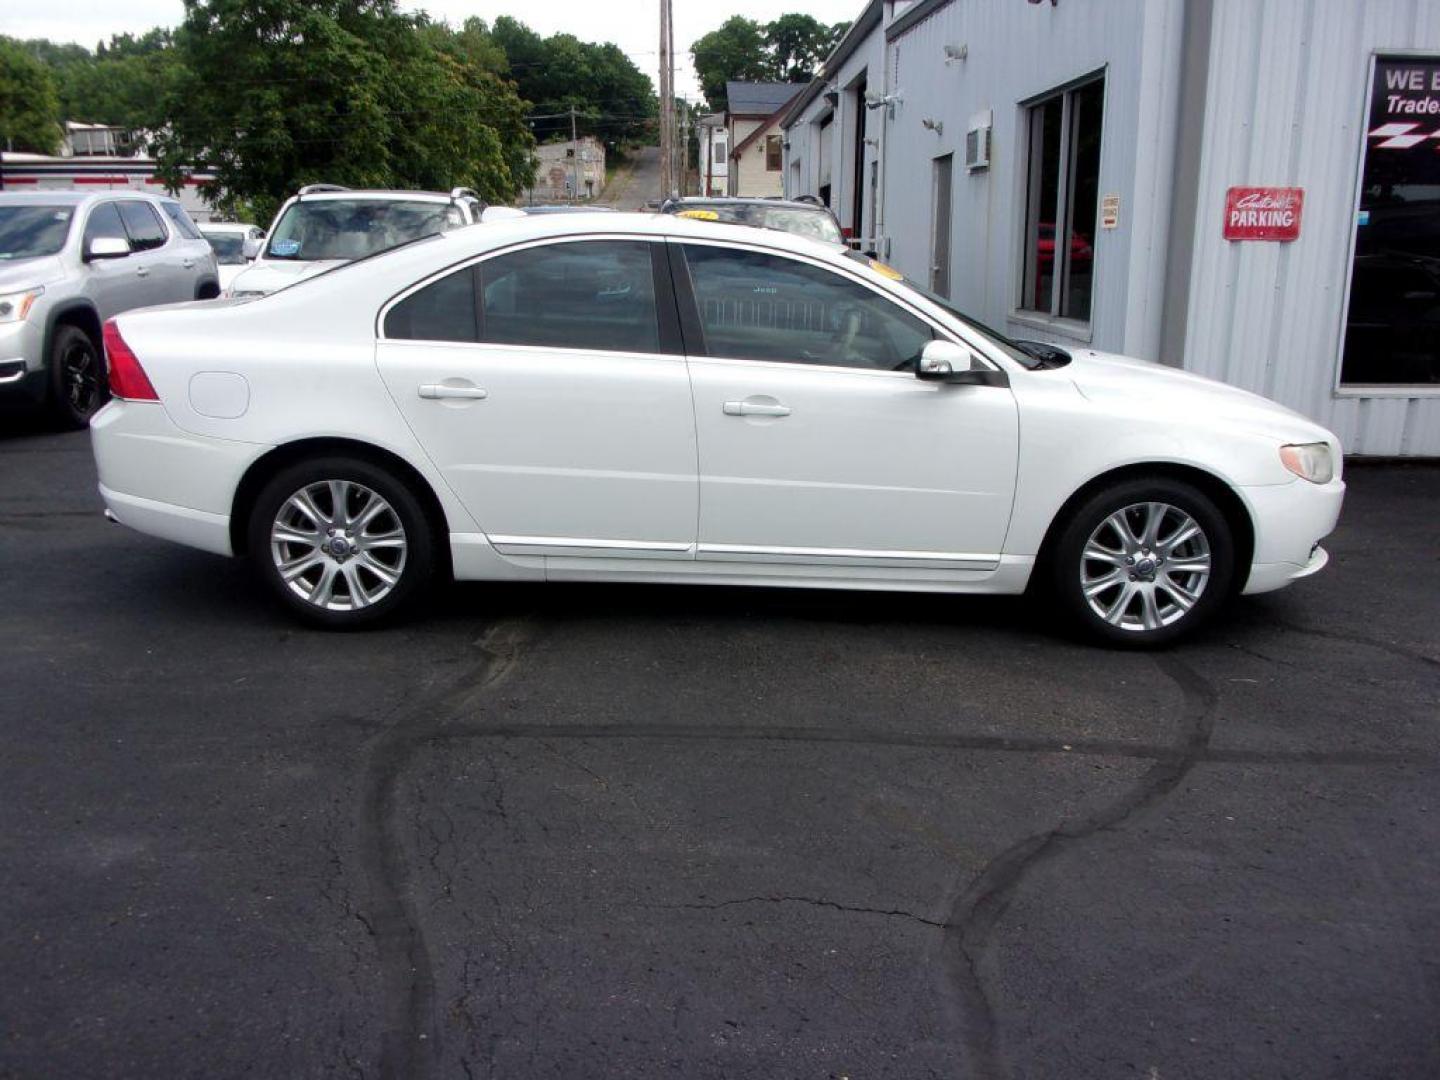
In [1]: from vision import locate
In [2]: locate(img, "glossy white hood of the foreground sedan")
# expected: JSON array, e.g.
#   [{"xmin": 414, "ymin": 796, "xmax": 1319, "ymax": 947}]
[{"xmin": 1063, "ymin": 348, "xmax": 1335, "ymax": 442}]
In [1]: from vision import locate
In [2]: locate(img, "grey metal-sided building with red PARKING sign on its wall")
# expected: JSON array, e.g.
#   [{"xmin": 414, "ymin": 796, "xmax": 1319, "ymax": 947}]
[{"xmin": 780, "ymin": 0, "xmax": 1440, "ymax": 456}]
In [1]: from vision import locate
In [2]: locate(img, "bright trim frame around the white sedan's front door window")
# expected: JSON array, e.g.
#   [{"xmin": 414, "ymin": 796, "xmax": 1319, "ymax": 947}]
[{"xmin": 668, "ymin": 236, "xmax": 1008, "ymax": 382}]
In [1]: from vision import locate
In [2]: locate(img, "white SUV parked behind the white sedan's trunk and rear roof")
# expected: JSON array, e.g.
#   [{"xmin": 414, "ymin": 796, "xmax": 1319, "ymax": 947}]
[{"xmin": 226, "ymin": 184, "xmax": 485, "ymax": 297}]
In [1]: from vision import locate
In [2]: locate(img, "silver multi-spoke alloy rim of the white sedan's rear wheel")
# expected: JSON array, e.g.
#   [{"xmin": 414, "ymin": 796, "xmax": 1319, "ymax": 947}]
[{"xmin": 271, "ymin": 480, "xmax": 408, "ymax": 611}]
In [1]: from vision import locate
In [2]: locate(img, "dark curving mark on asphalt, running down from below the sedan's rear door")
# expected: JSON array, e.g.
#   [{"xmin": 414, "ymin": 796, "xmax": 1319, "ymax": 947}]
[{"xmin": 357, "ymin": 619, "xmax": 530, "ymax": 1080}]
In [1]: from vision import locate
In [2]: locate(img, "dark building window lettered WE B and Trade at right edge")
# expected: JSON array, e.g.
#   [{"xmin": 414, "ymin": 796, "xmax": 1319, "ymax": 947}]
[{"xmin": 1341, "ymin": 56, "xmax": 1440, "ymax": 387}]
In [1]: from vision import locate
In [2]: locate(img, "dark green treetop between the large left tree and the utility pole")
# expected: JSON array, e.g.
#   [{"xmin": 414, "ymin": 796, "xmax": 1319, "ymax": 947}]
[{"xmin": 491, "ymin": 16, "xmax": 658, "ymax": 147}]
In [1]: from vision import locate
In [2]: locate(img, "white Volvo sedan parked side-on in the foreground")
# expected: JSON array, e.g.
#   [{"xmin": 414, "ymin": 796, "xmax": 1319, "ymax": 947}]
[{"xmin": 92, "ymin": 215, "xmax": 1344, "ymax": 645}]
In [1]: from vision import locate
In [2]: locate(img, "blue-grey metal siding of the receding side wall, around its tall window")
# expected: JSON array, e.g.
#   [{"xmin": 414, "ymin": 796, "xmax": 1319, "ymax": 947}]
[{"xmin": 864, "ymin": 0, "xmax": 1172, "ymax": 350}]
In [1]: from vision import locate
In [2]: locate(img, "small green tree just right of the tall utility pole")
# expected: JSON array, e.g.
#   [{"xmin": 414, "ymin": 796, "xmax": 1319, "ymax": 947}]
[{"xmin": 690, "ymin": 13, "xmax": 850, "ymax": 111}]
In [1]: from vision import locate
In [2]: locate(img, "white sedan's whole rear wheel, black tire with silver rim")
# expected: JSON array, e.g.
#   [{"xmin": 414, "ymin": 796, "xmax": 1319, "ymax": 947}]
[{"xmin": 246, "ymin": 455, "xmax": 439, "ymax": 629}]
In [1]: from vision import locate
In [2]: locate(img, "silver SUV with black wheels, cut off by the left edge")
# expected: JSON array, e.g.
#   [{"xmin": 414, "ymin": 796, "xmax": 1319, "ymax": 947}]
[{"xmin": 0, "ymin": 192, "xmax": 220, "ymax": 428}]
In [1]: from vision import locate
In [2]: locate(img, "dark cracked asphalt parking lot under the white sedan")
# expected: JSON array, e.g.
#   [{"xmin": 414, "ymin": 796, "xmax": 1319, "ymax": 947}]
[{"xmin": 0, "ymin": 420, "xmax": 1440, "ymax": 1080}]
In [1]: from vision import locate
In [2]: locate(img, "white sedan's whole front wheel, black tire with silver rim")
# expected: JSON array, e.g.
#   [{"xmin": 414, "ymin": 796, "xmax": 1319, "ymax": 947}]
[{"xmin": 1048, "ymin": 477, "xmax": 1236, "ymax": 648}]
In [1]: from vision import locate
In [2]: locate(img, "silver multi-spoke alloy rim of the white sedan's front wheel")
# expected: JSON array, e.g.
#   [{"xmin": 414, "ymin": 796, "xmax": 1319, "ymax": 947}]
[{"xmin": 1080, "ymin": 503, "xmax": 1210, "ymax": 632}]
